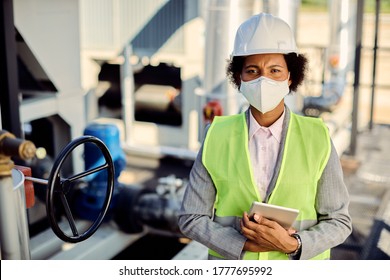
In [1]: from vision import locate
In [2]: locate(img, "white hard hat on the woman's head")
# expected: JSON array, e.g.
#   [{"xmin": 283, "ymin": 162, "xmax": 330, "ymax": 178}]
[{"xmin": 232, "ymin": 13, "xmax": 298, "ymax": 57}]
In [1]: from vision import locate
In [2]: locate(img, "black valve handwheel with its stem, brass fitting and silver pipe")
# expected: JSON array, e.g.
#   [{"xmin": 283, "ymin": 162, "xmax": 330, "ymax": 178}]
[{"xmin": 0, "ymin": 131, "xmax": 114, "ymax": 259}]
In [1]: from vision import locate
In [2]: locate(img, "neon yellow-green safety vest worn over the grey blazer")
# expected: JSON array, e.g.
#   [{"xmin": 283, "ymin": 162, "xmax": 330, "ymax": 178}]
[{"xmin": 202, "ymin": 113, "xmax": 331, "ymax": 259}]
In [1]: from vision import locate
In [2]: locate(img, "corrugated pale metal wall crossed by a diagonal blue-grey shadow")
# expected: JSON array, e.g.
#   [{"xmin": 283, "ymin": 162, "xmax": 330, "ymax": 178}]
[{"xmin": 80, "ymin": 0, "xmax": 187, "ymax": 56}]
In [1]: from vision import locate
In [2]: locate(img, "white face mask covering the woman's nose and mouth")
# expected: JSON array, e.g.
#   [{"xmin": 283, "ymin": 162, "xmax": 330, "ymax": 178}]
[{"xmin": 240, "ymin": 73, "xmax": 290, "ymax": 114}]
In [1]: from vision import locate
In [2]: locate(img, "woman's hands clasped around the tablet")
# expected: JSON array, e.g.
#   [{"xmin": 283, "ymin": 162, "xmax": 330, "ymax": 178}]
[{"xmin": 241, "ymin": 212, "xmax": 298, "ymax": 253}]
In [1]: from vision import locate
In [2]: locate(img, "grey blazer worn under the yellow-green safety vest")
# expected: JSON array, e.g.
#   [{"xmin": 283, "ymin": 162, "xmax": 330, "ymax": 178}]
[{"xmin": 178, "ymin": 107, "xmax": 352, "ymax": 260}]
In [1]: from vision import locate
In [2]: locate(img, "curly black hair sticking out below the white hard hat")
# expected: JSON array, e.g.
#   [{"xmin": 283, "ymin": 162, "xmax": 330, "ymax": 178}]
[{"xmin": 226, "ymin": 53, "xmax": 308, "ymax": 92}]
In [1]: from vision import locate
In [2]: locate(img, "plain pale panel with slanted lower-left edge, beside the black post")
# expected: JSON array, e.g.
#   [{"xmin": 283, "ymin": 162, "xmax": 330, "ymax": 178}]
[{"xmin": 14, "ymin": 0, "xmax": 81, "ymax": 94}]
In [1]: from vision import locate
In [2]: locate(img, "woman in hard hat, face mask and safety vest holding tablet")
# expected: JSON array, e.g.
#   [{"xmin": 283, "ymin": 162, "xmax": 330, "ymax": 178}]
[{"xmin": 179, "ymin": 13, "xmax": 352, "ymax": 259}]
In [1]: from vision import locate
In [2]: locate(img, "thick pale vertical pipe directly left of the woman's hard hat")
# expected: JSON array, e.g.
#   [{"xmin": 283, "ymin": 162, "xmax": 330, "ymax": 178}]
[{"xmin": 199, "ymin": 0, "xmax": 255, "ymax": 134}]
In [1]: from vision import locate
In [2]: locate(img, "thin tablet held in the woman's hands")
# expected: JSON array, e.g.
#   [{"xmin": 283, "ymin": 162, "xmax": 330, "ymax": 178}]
[{"xmin": 249, "ymin": 201, "xmax": 299, "ymax": 229}]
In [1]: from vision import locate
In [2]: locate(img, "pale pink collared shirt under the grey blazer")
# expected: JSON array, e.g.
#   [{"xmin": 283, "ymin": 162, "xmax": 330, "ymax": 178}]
[{"xmin": 248, "ymin": 111, "xmax": 285, "ymax": 200}]
